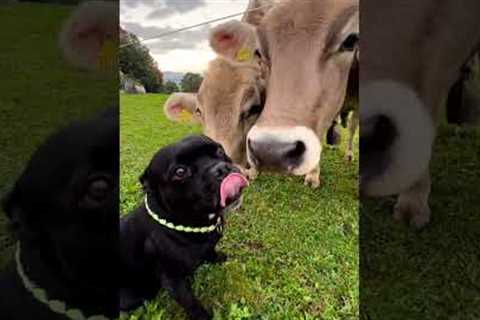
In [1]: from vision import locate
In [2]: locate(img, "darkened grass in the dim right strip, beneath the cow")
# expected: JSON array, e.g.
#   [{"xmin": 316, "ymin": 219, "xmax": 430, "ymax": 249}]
[{"xmin": 360, "ymin": 126, "xmax": 480, "ymax": 320}]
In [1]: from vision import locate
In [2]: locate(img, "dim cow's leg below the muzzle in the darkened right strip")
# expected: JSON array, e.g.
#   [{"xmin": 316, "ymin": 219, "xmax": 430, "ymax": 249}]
[{"xmin": 393, "ymin": 172, "xmax": 431, "ymax": 229}]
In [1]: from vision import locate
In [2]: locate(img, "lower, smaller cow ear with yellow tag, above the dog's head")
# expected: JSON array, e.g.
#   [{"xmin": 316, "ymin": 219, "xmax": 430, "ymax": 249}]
[{"xmin": 164, "ymin": 93, "xmax": 198, "ymax": 122}]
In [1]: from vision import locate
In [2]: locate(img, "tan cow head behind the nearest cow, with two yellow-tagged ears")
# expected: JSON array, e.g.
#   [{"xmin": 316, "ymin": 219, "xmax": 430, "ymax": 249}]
[{"xmin": 165, "ymin": 21, "xmax": 265, "ymax": 166}]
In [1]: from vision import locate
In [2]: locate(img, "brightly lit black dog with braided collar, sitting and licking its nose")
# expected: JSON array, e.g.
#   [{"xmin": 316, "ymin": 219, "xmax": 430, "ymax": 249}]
[{"xmin": 120, "ymin": 136, "xmax": 248, "ymax": 319}]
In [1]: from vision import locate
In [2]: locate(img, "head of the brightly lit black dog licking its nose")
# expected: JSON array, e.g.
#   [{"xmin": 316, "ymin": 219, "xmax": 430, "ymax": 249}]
[{"xmin": 140, "ymin": 136, "xmax": 248, "ymax": 224}]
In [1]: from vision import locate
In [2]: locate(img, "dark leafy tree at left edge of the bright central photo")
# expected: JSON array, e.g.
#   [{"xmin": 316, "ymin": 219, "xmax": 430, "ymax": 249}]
[{"xmin": 119, "ymin": 29, "xmax": 163, "ymax": 92}]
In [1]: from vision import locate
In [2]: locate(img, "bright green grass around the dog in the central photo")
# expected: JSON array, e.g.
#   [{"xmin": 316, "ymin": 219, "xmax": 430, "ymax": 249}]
[{"xmin": 120, "ymin": 95, "xmax": 358, "ymax": 320}]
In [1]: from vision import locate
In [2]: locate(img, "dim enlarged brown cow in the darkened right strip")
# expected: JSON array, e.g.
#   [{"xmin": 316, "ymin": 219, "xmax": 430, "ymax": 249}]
[{"xmin": 360, "ymin": 0, "xmax": 480, "ymax": 227}]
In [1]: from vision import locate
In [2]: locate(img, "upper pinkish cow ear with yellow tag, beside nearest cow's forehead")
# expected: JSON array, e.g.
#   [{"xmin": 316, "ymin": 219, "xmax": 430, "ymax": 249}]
[{"xmin": 210, "ymin": 20, "xmax": 258, "ymax": 63}]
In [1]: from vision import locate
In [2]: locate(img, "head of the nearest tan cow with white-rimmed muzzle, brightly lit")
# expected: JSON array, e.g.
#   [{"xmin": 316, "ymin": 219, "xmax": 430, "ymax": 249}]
[{"xmin": 244, "ymin": 0, "xmax": 359, "ymax": 175}]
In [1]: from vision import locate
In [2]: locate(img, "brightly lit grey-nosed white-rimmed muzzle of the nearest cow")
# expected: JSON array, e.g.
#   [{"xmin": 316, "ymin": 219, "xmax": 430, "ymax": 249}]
[{"xmin": 247, "ymin": 126, "xmax": 321, "ymax": 175}]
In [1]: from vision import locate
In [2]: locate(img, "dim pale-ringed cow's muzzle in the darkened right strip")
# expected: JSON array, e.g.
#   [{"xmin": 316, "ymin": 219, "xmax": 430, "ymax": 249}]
[{"xmin": 360, "ymin": 81, "xmax": 435, "ymax": 196}]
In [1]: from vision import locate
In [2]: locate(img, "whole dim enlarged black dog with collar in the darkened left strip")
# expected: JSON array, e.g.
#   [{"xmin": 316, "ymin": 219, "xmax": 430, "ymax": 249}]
[{"xmin": 0, "ymin": 109, "xmax": 119, "ymax": 320}]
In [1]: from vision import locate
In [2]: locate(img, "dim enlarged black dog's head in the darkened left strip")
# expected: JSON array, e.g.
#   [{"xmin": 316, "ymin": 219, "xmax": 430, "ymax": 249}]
[{"xmin": 4, "ymin": 110, "xmax": 119, "ymax": 288}]
